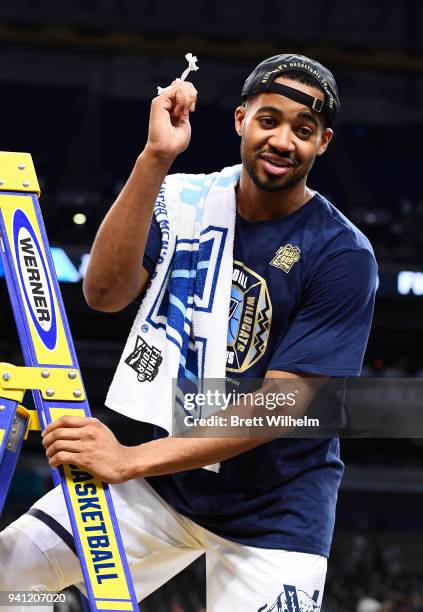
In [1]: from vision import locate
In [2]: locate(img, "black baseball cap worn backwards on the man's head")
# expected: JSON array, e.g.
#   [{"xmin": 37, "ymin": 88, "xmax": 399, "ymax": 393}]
[{"xmin": 241, "ymin": 53, "xmax": 341, "ymax": 126}]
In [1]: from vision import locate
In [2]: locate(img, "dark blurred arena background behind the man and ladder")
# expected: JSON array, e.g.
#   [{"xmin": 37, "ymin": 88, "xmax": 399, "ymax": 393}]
[{"xmin": 0, "ymin": 0, "xmax": 423, "ymax": 612}]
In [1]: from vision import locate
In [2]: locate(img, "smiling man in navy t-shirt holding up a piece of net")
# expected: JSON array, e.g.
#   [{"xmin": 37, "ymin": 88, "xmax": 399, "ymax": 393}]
[{"xmin": 0, "ymin": 55, "xmax": 376, "ymax": 612}]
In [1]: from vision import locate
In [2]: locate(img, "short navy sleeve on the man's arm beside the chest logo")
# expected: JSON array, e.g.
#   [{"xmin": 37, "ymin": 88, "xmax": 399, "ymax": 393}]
[{"xmin": 268, "ymin": 248, "xmax": 377, "ymax": 376}]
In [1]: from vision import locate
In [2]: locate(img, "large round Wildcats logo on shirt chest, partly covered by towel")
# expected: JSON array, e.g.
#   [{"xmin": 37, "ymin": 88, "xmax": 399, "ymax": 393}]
[{"xmin": 226, "ymin": 261, "xmax": 272, "ymax": 372}]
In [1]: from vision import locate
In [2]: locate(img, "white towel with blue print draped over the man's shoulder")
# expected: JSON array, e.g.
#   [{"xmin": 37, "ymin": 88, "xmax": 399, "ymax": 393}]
[{"xmin": 106, "ymin": 165, "xmax": 241, "ymax": 468}]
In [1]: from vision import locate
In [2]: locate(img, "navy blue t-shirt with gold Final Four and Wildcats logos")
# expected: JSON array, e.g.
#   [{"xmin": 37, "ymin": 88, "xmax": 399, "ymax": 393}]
[{"xmin": 144, "ymin": 184, "xmax": 377, "ymax": 556}]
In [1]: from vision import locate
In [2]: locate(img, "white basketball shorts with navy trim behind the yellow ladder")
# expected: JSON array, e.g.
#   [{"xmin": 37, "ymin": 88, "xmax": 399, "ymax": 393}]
[{"xmin": 0, "ymin": 478, "xmax": 327, "ymax": 612}]
